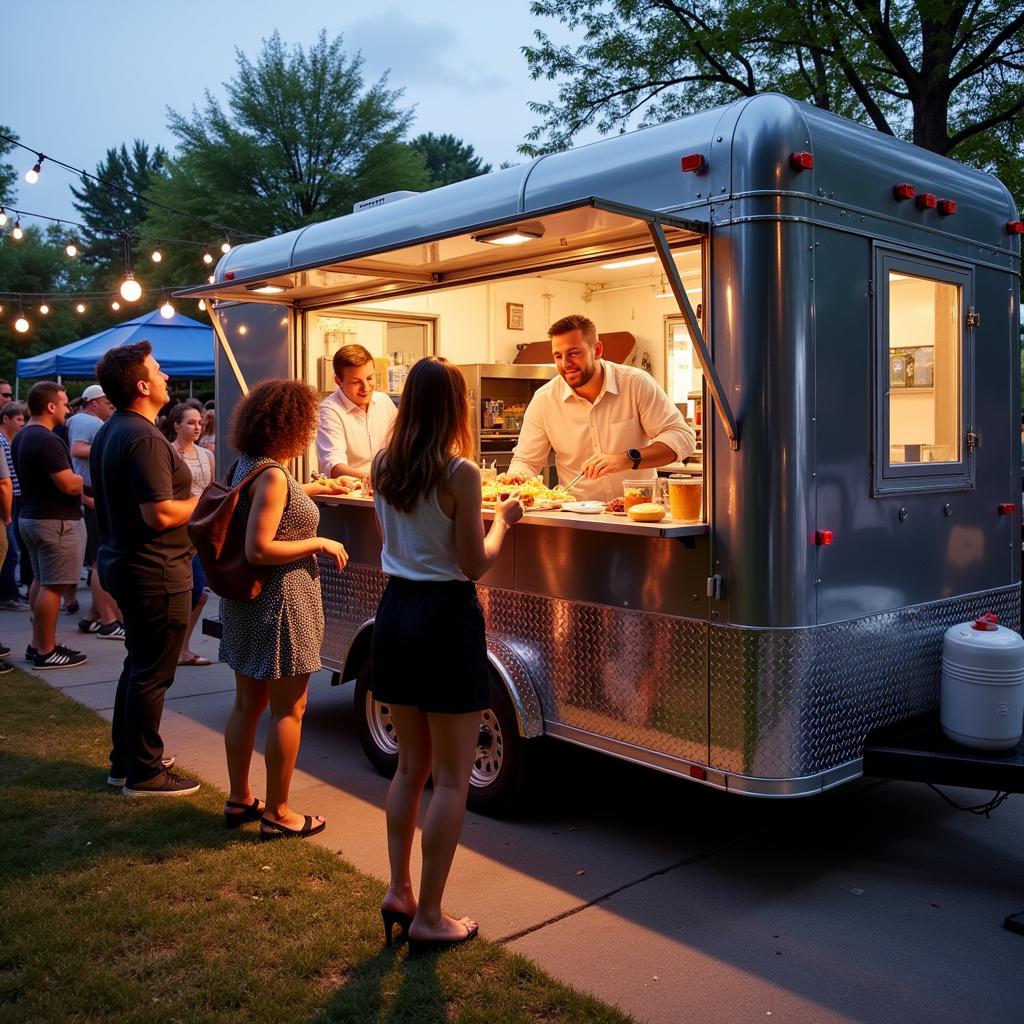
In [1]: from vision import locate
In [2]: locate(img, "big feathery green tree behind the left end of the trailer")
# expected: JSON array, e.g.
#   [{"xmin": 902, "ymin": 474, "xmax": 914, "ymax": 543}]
[{"xmin": 138, "ymin": 32, "xmax": 430, "ymax": 281}]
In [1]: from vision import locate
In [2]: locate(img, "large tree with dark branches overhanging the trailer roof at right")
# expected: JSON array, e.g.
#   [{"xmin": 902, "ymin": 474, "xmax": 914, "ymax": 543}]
[{"xmin": 520, "ymin": 0, "xmax": 1024, "ymax": 192}]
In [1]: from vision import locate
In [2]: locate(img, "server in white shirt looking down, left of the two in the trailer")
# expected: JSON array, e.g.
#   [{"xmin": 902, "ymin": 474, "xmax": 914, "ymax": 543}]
[{"xmin": 316, "ymin": 345, "xmax": 397, "ymax": 483}]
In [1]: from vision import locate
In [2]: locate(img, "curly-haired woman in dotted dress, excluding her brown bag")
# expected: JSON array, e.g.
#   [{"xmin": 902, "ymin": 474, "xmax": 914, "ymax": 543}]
[{"xmin": 220, "ymin": 380, "xmax": 348, "ymax": 839}]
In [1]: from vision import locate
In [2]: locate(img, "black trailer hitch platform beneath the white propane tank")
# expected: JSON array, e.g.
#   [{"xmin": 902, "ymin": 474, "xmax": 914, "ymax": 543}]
[{"xmin": 864, "ymin": 712, "xmax": 1024, "ymax": 793}]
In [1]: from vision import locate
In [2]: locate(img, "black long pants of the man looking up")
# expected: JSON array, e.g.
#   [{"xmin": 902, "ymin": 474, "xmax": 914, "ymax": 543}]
[{"xmin": 107, "ymin": 580, "xmax": 191, "ymax": 785}]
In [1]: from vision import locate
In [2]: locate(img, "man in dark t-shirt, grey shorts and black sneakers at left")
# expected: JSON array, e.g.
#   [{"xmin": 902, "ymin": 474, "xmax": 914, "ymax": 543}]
[{"xmin": 11, "ymin": 381, "xmax": 87, "ymax": 669}]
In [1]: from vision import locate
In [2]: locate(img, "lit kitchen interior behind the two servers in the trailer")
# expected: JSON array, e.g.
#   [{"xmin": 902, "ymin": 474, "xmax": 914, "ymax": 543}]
[{"xmin": 305, "ymin": 245, "xmax": 705, "ymax": 484}]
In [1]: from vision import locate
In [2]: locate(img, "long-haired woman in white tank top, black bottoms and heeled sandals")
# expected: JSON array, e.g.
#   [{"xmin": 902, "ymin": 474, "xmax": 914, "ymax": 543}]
[{"xmin": 373, "ymin": 356, "xmax": 522, "ymax": 951}]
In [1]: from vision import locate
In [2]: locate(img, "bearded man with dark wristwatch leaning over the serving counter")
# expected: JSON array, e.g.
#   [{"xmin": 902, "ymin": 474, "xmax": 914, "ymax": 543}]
[{"xmin": 509, "ymin": 313, "xmax": 696, "ymax": 502}]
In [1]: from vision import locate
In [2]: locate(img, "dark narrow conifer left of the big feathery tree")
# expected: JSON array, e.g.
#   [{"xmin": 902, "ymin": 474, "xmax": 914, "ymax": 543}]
[{"xmin": 71, "ymin": 138, "xmax": 167, "ymax": 276}]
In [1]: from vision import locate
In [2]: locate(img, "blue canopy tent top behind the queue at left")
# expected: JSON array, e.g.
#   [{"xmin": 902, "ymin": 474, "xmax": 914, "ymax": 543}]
[{"xmin": 16, "ymin": 309, "xmax": 213, "ymax": 380}]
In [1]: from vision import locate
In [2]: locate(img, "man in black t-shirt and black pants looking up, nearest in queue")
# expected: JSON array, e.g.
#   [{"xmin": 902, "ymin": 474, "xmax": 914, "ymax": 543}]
[{"xmin": 89, "ymin": 341, "xmax": 199, "ymax": 797}]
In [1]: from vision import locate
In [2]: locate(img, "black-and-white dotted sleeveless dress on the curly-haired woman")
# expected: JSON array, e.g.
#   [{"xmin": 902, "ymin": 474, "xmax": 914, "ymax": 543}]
[{"xmin": 220, "ymin": 456, "xmax": 324, "ymax": 679}]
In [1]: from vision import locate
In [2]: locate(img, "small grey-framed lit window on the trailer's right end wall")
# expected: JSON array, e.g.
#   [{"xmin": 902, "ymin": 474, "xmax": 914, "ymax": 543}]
[{"xmin": 874, "ymin": 251, "xmax": 973, "ymax": 495}]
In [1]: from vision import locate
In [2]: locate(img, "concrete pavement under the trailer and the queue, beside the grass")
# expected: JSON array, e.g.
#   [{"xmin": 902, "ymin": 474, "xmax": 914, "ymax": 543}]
[{"xmin": 9, "ymin": 590, "xmax": 1024, "ymax": 1024}]
